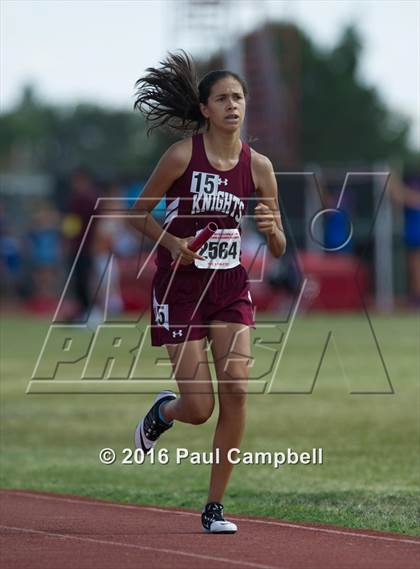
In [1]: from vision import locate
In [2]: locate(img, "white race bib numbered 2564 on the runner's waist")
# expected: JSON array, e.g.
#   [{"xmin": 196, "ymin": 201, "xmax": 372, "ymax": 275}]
[{"xmin": 194, "ymin": 229, "xmax": 241, "ymax": 269}]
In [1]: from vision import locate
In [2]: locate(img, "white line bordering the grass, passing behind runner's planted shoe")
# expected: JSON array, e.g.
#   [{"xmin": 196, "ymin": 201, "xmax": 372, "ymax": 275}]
[{"xmin": 0, "ymin": 489, "xmax": 420, "ymax": 547}]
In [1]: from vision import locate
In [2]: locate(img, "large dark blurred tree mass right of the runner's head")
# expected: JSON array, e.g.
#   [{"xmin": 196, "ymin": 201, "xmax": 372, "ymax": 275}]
[{"xmin": 205, "ymin": 23, "xmax": 413, "ymax": 167}]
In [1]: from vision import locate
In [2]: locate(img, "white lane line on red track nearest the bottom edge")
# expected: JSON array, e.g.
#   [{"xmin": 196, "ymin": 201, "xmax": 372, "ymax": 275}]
[{"xmin": 0, "ymin": 525, "xmax": 279, "ymax": 569}]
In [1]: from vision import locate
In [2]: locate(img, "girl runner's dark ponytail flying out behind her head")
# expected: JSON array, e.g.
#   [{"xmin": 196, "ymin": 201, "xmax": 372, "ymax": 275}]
[{"xmin": 134, "ymin": 50, "xmax": 205, "ymax": 134}]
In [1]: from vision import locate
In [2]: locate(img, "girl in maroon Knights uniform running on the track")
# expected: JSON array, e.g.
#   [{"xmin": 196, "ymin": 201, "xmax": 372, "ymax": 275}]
[{"xmin": 133, "ymin": 52, "xmax": 286, "ymax": 533}]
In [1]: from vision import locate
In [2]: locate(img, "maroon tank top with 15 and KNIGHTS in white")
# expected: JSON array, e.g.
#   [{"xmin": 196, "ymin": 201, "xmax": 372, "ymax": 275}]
[{"xmin": 156, "ymin": 134, "xmax": 255, "ymax": 270}]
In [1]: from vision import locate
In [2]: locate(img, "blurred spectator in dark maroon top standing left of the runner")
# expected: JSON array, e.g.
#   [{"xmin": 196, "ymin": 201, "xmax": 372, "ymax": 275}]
[{"xmin": 63, "ymin": 169, "xmax": 97, "ymax": 320}]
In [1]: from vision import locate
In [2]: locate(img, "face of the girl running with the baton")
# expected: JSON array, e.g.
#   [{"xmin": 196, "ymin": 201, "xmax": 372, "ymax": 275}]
[{"xmin": 200, "ymin": 77, "xmax": 246, "ymax": 132}]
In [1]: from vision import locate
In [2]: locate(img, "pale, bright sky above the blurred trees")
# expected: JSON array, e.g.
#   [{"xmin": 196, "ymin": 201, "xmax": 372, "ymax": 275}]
[{"xmin": 0, "ymin": 0, "xmax": 420, "ymax": 147}]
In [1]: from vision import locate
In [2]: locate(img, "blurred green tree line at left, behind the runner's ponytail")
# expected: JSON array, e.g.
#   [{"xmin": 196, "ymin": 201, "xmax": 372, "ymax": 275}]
[{"xmin": 0, "ymin": 87, "xmax": 171, "ymax": 179}]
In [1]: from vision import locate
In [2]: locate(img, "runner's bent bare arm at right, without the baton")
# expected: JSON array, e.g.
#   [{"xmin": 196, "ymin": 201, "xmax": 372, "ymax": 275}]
[{"xmin": 251, "ymin": 151, "xmax": 286, "ymax": 257}]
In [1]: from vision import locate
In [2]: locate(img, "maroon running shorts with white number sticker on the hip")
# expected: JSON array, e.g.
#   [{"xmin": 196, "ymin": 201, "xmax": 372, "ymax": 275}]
[{"xmin": 151, "ymin": 265, "xmax": 255, "ymax": 346}]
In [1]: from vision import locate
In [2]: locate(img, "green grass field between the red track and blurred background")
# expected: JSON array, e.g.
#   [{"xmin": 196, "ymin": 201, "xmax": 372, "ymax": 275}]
[{"xmin": 1, "ymin": 315, "xmax": 420, "ymax": 535}]
